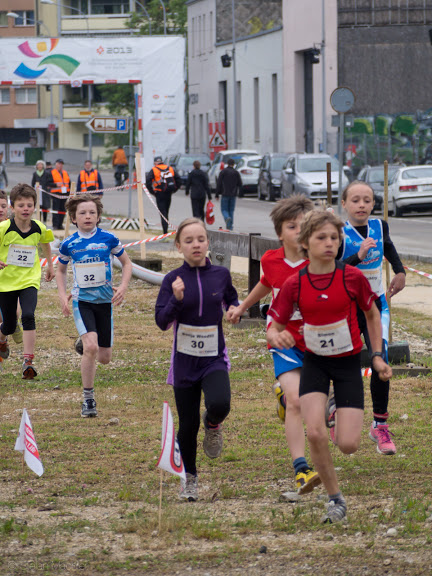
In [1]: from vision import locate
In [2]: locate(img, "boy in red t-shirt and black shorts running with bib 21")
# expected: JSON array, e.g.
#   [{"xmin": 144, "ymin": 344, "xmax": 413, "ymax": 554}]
[{"xmin": 267, "ymin": 211, "xmax": 391, "ymax": 523}]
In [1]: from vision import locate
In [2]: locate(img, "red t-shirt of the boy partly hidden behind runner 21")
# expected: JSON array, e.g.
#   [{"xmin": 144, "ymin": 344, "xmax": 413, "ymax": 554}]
[{"xmin": 261, "ymin": 246, "xmax": 309, "ymax": 350}]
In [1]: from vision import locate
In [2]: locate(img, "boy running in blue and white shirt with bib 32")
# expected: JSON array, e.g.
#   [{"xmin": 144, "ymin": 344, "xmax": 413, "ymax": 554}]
[{"xmin": 56, "ymin": 194, "xmax": 132, "ymax": 418}]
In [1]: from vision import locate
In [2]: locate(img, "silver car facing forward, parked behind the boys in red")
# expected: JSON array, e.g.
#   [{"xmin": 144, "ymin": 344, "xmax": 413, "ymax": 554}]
[{"xmin": 281, "ymin": 153, "xmax": 348, "ymax": 202}]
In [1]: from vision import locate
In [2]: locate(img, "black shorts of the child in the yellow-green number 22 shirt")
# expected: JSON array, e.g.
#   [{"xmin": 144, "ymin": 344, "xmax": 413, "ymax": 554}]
[{"xmin": 0, "ymin": 286, "xmax": 37, "ymax": 336}]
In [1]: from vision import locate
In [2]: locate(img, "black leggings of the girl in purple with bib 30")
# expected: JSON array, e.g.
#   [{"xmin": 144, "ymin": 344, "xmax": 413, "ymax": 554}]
[{"xmin": 174, "ymin": 370, "xmax": 231, "ymax": 475}]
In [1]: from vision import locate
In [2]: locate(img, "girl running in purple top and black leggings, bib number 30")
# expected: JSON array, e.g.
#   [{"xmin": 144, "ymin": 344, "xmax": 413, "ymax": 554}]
[{"xmin": 156, "ymin": 218, "xmax": 238, "ymax": 501}]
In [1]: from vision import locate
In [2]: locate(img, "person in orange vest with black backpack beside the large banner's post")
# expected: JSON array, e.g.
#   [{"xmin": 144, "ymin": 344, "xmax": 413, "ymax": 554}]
[{"xmin": 146, "ymin": 156, "xmax": 181, "ymax": 234}]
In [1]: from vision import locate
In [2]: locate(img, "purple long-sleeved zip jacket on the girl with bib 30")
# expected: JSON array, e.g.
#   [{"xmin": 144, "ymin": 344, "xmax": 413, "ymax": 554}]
[{"xmin": 156, "ymin": 259, "xmax": 238, "ymax": 388}]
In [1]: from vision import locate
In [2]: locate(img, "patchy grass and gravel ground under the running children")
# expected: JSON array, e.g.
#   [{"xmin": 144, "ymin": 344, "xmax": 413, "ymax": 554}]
[{"xmin": 0, "ymin": 254, "xmax": 432, "ymax": 576}]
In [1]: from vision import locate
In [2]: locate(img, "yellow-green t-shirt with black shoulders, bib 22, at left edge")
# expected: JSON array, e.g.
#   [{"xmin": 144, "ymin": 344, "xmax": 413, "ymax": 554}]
[{"xmin": 0, "ymin": 218, "xmax": 54, "ymax": 292}]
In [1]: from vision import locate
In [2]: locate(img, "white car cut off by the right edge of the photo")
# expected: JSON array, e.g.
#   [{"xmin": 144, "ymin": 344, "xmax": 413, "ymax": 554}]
[{"xmin": 389, "ymin": 165, "xmax": 432, "ymax": 216}]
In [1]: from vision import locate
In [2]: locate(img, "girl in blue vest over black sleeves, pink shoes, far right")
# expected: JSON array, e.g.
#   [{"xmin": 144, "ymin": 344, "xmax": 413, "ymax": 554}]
[{"xmin": 329, "ymin": 181, "xmax": 405, "ymax": 455}]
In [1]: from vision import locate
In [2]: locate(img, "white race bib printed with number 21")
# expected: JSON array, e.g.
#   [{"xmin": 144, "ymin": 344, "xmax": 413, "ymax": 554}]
[{"xmin": 304, "ymin": 318, "xmax": 353, "ymax": 356}]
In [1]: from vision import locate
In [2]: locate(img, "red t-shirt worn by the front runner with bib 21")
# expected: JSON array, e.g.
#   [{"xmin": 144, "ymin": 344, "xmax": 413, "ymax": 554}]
[{"xmin": 268, "ymin": 264, "xmax": 378, "ymax": 356}]
